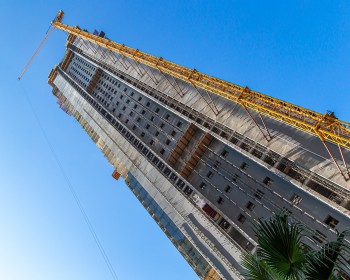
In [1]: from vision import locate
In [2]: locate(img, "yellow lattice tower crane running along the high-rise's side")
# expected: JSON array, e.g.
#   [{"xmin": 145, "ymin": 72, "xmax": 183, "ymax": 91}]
[{"xmin": 18, "ymin": 11, "xmax": 350, "ymax": 180}]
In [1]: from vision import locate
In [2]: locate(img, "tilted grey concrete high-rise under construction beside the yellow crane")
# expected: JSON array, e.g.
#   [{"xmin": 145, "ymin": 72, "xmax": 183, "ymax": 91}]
[{"xmin": 49, "ymin": 14, "xmax": 350, "ymax": 279}]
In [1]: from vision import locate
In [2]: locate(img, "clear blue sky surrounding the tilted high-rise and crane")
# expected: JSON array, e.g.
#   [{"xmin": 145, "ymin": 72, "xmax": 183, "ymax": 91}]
[{"xmin": 0, "ymin": 0, "xmax": 350, "ymax": 280}]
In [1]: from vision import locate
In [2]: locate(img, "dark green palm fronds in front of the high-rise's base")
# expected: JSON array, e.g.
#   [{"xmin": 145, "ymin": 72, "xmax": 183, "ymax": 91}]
[{"xmin": 242, "ymin": 212, "xmax": 350, "ymax": 280}]
